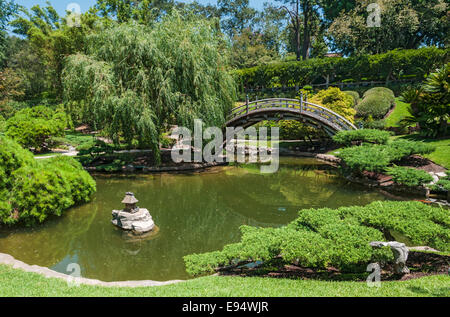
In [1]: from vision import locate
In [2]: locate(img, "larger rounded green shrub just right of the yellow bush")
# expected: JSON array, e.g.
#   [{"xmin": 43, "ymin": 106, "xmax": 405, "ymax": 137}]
[{"xmin": 356, "ymin": 87, "xmax": 395, "ymax": 119}]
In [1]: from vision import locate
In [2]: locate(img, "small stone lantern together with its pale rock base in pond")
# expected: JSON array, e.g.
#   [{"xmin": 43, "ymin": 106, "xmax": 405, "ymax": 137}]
[{"xmin": 111, "ymin": 192, "xmax": 155, "ymax": 235}]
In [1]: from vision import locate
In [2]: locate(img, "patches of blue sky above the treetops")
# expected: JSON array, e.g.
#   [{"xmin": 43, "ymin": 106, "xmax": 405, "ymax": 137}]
[{"xmin": 15, "ymin": 0, "xmax": 267, "ymax": 15}]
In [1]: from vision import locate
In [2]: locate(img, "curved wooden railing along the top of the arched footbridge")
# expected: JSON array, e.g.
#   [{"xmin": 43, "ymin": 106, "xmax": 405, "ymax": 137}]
[{"xmin": 227, "ymin": 98, "xmax": 357, "ymax": 130}]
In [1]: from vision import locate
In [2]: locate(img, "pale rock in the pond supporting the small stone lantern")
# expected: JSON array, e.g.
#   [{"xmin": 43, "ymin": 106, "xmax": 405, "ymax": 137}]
[{"xmin": 111, "ymin": 208, "xmax": 155, "ymax": 234}]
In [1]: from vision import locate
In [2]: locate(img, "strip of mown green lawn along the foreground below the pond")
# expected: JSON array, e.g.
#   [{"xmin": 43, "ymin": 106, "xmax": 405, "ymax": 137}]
[{"xmin": 0, "ymin": 265, "xmax": 450, "ymax": 297}]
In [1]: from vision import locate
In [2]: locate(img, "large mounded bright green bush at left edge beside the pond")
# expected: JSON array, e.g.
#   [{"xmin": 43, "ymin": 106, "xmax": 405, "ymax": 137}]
[{"xmin": 0, "ymin": 136, "xmax": 96, "ymax": 225}]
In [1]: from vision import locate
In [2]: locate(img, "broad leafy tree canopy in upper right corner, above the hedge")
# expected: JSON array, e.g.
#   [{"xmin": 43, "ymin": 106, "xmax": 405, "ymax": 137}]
[{"xmin": 328, "ymin": 0, "xmax": 450, "ymax": 54}]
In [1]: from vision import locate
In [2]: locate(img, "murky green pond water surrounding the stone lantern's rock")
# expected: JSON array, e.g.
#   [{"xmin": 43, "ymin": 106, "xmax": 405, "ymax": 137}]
[{"xmin": 0, "ymin": 158, "xmax": 396, "ymax": 281}]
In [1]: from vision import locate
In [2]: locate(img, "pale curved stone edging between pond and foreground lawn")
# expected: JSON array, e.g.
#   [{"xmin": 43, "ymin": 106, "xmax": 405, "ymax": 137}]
[{"xmin": 0, "ymin": 253, "xmax": 185, "ymax": 288}]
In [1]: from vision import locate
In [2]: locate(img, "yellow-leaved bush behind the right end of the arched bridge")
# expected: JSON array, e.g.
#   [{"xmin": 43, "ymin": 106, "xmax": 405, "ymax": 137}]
[{"xmin": 311, "ymin": 87, "xmax": 356, "ymax": 122}]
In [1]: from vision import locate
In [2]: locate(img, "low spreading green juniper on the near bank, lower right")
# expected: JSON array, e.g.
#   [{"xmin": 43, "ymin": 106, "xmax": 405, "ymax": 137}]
[{"xmin": 184, "ymin": 202, "xmax": 450, "ymax": 275}]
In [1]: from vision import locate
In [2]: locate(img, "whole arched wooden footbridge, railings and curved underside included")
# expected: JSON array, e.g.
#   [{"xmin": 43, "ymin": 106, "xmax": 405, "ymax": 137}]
[{"xmin": 225, "ymin": 98, "xmax": 356, "ymax": 135}]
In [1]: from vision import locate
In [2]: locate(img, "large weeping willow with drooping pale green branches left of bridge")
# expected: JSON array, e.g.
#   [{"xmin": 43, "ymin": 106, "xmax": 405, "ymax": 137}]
[{"xmin": 63, "ymin": 12, "xmax": 236, "ymax": 162}]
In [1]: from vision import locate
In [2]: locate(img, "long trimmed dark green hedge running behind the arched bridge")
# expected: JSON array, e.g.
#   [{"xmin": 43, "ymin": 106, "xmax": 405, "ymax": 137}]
[{"xmin": 233, "ymin": 47, "xmax": 450, "ymax": 89}]
